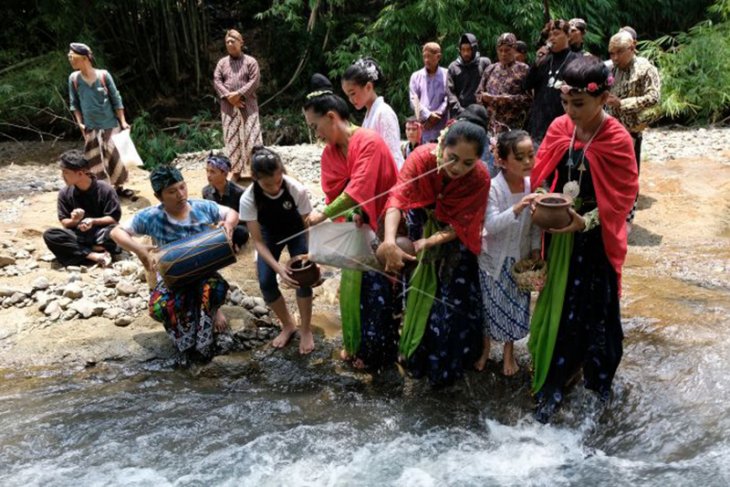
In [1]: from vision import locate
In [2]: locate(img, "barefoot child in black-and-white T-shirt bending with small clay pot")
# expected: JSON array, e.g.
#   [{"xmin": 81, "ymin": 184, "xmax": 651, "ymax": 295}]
[{"xmin": 240, "ymin": 147, "xmax": 314, "ymax": 354}]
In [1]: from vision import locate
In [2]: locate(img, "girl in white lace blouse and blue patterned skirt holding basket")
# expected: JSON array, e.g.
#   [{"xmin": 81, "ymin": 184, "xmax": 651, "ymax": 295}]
[{"xmin": 475, "ymin": 130, "xmax": 540, "ymax": 376}]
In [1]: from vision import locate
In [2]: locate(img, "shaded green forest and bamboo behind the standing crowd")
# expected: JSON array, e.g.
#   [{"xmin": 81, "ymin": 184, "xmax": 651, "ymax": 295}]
[{"xmin": 0, "ymin": 0, "xmax": 730, "ymax": 161}]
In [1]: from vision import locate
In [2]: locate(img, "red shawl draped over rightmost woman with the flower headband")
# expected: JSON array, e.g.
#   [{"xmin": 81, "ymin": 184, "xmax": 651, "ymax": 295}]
[{"xmin": 531, "ymin": 115, "xmax": 639, "ymax": 289}]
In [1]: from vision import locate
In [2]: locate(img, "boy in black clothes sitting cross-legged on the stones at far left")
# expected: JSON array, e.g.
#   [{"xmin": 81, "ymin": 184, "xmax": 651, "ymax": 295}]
[{"xmin": 43, "ymin": 150, "xmax": 122, "ymax": 266}]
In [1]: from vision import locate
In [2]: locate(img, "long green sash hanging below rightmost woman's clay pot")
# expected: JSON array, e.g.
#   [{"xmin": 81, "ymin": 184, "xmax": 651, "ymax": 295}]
[{"xmin": 527, "ymin": 233, "xmax": 574, "ymax": 394}]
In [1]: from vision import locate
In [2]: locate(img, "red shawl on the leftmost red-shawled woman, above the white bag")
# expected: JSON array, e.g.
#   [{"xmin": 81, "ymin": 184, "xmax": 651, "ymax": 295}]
[{"xmin": 321, "ymin": 128, "xmax": 398, "ymax": 231}]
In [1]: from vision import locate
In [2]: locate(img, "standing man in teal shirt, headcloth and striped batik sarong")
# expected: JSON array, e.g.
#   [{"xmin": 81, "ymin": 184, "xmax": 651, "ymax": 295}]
[{"xmin": 68, "ymin": 42, "xmax": 134, "ymax": 197}]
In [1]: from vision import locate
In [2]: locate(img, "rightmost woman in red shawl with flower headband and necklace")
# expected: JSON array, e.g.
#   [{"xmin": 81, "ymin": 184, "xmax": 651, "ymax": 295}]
[{"xmin": 528, "ymin": 56, "xmax": 639, "ymax": 422}]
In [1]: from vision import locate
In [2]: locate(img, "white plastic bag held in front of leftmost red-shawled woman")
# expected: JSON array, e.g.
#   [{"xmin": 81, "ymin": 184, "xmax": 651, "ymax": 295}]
[{"xmin": 309, "ymin": 222, "xmax": 383, "ymax": 271}]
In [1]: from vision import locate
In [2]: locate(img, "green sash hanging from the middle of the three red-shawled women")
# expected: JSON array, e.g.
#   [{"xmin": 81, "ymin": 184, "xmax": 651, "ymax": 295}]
[{"xmin": 398, "ymin": 211, "xmax": 439, "ymax": 358}]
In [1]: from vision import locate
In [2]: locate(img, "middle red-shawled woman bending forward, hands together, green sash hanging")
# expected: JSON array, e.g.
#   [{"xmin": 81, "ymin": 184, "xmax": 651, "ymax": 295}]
[{"xmin": 378, "ymin": 108, "xmax": 489, "ymax": 386}]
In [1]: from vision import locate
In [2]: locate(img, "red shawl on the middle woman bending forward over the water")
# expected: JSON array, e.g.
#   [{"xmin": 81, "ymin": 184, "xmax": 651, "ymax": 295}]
[{"xmin": 386, "ymin": 144, "xmax": 490, "ymax": 254}]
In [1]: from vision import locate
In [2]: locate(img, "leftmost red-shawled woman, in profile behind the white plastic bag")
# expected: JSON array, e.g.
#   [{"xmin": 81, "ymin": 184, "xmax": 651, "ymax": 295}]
[{"xmin": 304, "ymin": 74, "xmax": 398, "ymax": 369}]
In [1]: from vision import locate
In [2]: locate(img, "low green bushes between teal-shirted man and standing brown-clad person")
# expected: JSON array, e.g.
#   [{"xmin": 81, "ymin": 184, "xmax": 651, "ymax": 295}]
[{"xmin": 132, "ymin": 112, "xmax": 223, "ymax": 169}]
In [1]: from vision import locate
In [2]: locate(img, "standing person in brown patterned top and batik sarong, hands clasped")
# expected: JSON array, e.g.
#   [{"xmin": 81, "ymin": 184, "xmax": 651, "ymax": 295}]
[{"xmin": 213, "ymin": 29, "xmax": 263, "ymax": 182}]
